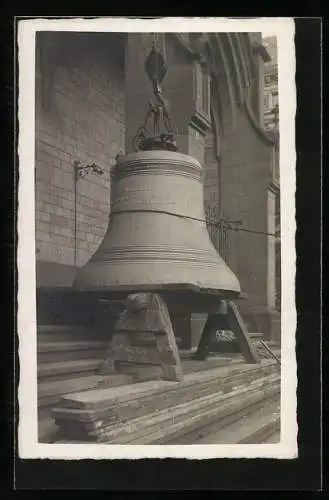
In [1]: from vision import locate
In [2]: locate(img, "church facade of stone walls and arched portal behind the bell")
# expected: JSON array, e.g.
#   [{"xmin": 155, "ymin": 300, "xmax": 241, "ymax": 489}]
[{"xmin": 35, "ymin": 32, "xmax": 280, "ymax": 348}]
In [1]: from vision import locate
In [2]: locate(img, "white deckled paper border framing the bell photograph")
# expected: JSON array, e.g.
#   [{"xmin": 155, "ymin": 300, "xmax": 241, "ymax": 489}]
[{"xmin": 17, "ymin": 18, "xmax": 298, "ymax": 460}]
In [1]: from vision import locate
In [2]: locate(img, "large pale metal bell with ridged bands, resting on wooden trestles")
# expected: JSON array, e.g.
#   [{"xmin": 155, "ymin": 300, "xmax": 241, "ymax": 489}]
[{"xmin": 75, "ymin": 149, "xmax": 240, "ymax": 295}]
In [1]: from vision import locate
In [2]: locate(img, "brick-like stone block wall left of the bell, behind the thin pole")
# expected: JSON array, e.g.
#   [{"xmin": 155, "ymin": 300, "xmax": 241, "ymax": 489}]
[{"xmin": 35, "ymin": 34, "xmax": 125, "ymax": 286}]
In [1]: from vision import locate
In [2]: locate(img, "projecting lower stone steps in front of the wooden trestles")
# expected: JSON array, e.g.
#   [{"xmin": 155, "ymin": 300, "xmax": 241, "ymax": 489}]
[{"xmin": 53, "ymin": 360, "xmax": 280, "ymax": 444}]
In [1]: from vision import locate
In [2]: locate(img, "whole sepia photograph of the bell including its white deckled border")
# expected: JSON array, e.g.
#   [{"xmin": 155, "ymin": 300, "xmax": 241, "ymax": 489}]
[{"xmin": 19, "ymin": 19, "xmax": 297, "ymax": 458}]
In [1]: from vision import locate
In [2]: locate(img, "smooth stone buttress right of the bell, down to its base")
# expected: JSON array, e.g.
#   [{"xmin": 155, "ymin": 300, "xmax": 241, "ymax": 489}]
[{"xmin": 221, "ymin": 108, "xmax": 280, "ymax": 338}]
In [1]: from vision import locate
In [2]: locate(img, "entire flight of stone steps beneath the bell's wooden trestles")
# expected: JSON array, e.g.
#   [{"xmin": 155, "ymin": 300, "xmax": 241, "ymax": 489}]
[{"xmin": 38, "ymin": 326, "xmax": 280, "ymax": 444}]
